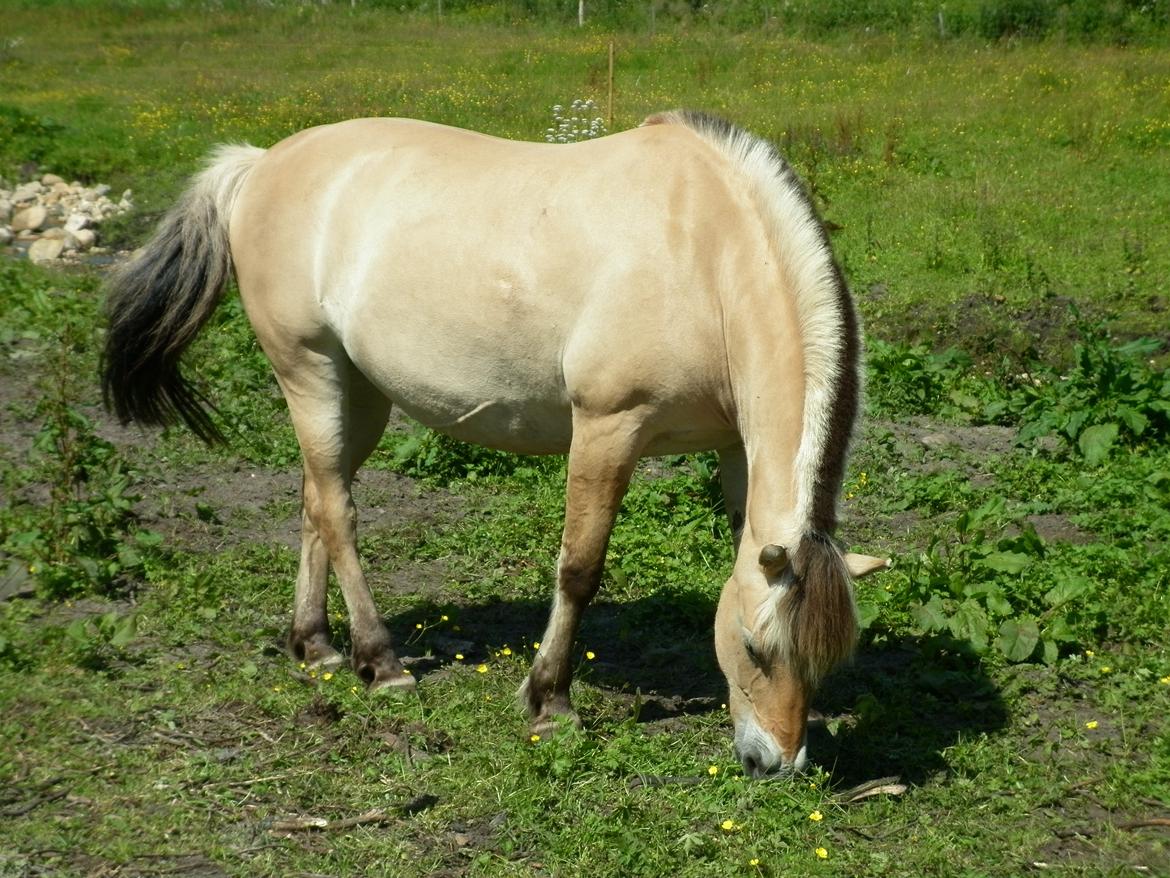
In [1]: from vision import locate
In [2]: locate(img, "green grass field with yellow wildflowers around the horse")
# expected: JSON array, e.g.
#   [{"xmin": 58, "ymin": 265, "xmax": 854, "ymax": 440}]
[{"xmin": 0, "ymin": 4, "xmax": 1170, "ymax": 876}]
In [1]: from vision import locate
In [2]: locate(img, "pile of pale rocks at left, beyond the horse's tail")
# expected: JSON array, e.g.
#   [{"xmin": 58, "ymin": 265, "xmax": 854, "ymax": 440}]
[{"xmin": 0, "ymin": 173, "xmax": 133, "ymax": 262}]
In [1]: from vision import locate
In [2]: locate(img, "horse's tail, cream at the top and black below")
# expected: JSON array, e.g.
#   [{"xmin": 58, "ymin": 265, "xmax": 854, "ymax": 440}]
[{"xmin": 102, "ymin": 145, "xmax": 264, "ymax": 443}]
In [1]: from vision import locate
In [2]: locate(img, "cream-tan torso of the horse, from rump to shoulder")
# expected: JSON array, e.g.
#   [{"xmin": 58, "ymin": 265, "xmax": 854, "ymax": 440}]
[{"xmin": 232, "ymin": 119, "xmax": 759, "ymax": 452}]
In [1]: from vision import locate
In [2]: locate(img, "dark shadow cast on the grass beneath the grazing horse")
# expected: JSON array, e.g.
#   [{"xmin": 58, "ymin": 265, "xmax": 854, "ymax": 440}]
[{"xmin": 386, "ymin": 591, "xmax": 1007, "ymax": 788}]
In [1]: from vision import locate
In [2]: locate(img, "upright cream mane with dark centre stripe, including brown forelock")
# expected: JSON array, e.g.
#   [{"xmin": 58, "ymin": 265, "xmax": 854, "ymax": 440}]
[{"xmin": 644, "ymin": 110, "xmax": 862, "ymax": 681}]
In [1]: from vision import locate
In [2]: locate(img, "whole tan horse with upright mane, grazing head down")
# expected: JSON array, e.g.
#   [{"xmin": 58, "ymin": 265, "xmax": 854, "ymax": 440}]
[{"xmin": 102, "ymin": 111, "xmax": 887, "ymax": 776}]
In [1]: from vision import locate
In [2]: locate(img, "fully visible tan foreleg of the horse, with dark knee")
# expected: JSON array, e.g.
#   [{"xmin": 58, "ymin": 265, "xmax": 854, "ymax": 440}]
[{"xmin": 521, "ymin": 411, "xmax": 644, "ymax": 732}]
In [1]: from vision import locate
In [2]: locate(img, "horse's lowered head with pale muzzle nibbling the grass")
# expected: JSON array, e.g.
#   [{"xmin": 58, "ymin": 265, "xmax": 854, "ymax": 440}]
[{"xmin": 715, "ymin": 535, "xmax": 889, "ymax": 777}]
